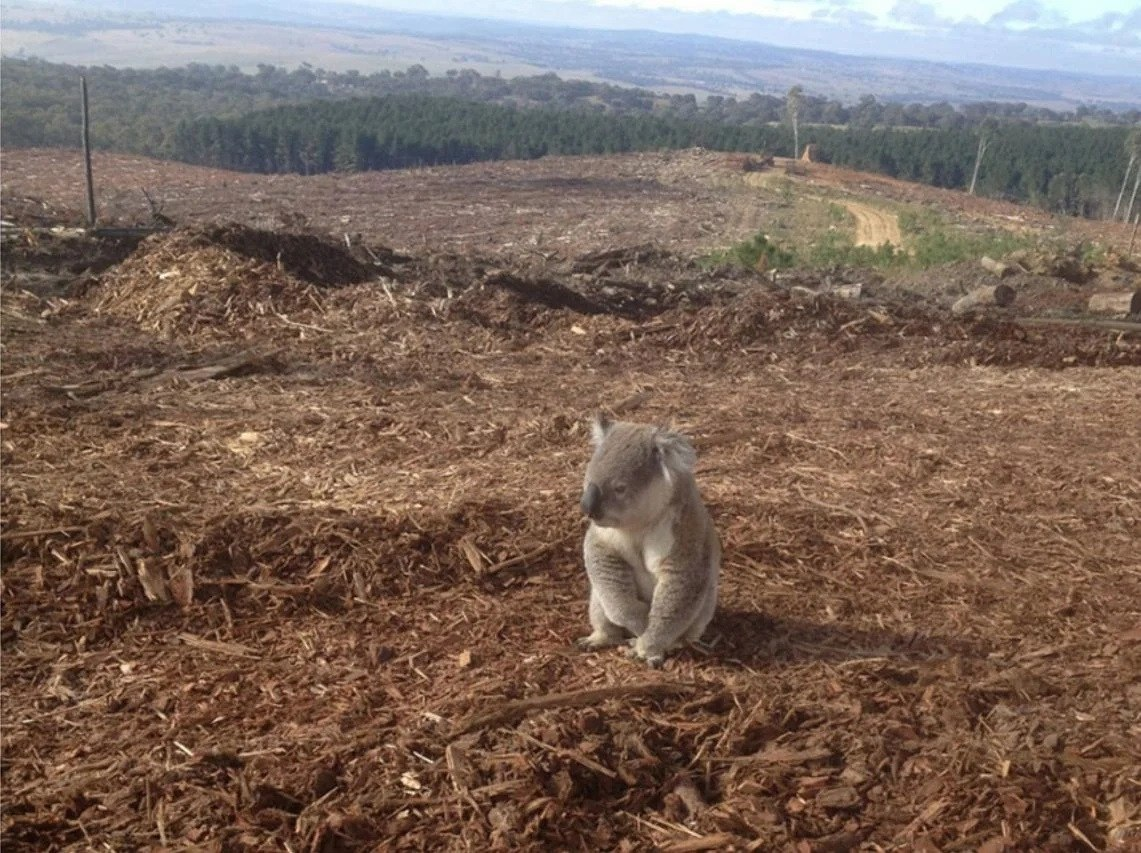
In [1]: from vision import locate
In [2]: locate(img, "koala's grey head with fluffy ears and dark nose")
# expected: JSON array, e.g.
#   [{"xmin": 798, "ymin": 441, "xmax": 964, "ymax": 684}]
[{"xmin": 581, "ymin": 422, "xmax": 673, "ymax": 528}]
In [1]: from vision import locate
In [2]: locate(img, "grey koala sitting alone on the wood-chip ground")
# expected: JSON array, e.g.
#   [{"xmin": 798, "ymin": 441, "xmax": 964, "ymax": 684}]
[{"xmin": 578, "ymin": 415, "xmax": 721, "ymax": 668}]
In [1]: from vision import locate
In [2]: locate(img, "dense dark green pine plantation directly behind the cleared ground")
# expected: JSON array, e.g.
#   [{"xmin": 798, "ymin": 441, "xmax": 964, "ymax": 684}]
[{"xmin": 171, "ymin": 95, "xmax": 1130, "ymax": 217}]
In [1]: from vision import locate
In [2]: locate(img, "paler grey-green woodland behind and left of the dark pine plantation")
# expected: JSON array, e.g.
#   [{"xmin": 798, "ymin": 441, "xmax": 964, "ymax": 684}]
[{"xmin": 0, "ymin": 58, "xmax": 1141, "ymax": 157}]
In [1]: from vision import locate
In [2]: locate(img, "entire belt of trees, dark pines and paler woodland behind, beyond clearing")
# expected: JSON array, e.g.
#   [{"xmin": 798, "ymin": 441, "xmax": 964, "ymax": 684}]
[{"xmin": 0, "ymin": 59, "xmax": 1141, "ymax": 217}]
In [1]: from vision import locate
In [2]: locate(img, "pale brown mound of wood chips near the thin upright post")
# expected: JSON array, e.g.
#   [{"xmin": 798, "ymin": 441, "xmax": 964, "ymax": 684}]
[{"xmin": 95, "ymin": 229, "xmax": 330, "ymax": 334}]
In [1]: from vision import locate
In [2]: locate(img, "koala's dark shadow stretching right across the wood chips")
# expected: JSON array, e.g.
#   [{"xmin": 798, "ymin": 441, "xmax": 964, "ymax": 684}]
[{"xmin": 704, "ymin": 608, "xmax": 988, "ymax": 668}]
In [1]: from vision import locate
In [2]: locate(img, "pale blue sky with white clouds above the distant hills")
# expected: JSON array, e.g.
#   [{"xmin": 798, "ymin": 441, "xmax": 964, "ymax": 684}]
[{"xmin": 348, "ymin": 0, "xmax": 1141, "ymax": 78}]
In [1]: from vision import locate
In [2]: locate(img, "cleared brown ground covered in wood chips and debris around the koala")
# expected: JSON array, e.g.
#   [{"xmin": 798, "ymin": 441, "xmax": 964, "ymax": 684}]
[{"xmin": 0, "ymin": 152, "xmax": 1141, "ymax": 853}]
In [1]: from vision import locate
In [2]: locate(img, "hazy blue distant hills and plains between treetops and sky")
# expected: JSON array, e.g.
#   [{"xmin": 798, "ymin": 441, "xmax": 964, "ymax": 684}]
[{"xmin": 3, "ymin": 0, "xmax": 1141, "ymax": 111}]
